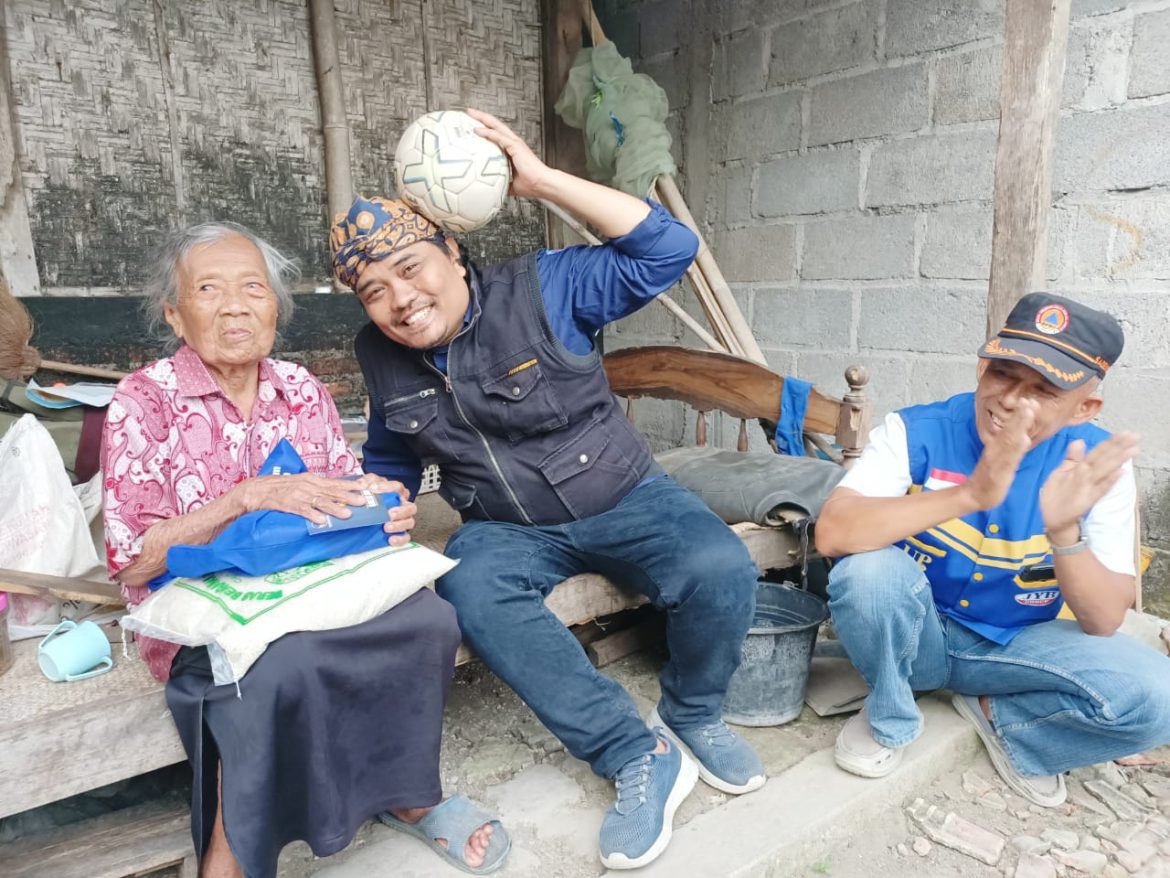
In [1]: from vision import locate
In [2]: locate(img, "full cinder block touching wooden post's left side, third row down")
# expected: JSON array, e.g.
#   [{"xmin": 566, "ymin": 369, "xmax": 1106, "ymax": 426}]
[{"xmin": 865, "ymin": 130, "xmax": 996, "ymax": 207}]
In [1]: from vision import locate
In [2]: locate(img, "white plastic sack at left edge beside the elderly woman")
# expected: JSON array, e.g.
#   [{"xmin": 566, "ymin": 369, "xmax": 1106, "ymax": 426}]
[{"xmin": 0, "ymin": 414, "xmax": 102, "ymax": 627}]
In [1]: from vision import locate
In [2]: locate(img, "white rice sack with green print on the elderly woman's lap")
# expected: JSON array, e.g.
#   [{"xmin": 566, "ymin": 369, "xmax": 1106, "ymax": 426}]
[{"xmin": 122, "ymin": 543, "xmax": 459, "ymax": 685}]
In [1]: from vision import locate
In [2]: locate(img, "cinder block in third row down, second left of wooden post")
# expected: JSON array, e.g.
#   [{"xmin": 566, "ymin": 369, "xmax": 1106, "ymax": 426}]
[{"xmin": 756, "ymin": 149, "xmax": 861, "ymax": 217}]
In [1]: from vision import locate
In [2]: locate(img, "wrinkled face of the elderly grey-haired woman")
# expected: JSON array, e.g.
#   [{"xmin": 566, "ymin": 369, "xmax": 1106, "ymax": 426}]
[{"xmin": 165, "ymin": 234, "xmax": 277, "ymax": 372}]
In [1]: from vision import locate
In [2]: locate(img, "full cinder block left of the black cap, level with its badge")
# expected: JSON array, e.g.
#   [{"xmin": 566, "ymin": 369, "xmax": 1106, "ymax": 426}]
[{"xmin": 858, "ymin": 287, "xmax": 987, "ymax": 355}]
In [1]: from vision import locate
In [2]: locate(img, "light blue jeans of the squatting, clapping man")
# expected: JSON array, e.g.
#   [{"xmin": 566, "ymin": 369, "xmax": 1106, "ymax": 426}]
[{"xmin": 828, "ymin": 548, "xmax": 1170, "ymax": 776}]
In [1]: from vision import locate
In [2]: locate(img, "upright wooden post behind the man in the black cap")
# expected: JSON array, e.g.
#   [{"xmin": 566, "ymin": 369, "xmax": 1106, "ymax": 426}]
[{"xmin": 987, "ymin": 0, "xmax": 1069, "ymax": 337}]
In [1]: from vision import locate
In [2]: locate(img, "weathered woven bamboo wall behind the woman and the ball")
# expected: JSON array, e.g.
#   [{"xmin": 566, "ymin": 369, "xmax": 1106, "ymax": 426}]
[{"xmin": 0, "ymin": 0, "xmax": 543, "ymax": 295}]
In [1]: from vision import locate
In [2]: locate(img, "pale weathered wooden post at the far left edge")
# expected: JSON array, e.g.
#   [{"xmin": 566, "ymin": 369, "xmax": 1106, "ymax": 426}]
[{"xmin": 0, "ymin": 2, "xmax": 41, "ymax": 296}]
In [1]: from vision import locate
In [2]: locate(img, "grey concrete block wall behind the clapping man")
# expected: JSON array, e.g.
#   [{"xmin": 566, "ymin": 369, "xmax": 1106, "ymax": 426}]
[{"xmin": 598, "ymin": 0, "xmax": 1170, "ymax": 615}]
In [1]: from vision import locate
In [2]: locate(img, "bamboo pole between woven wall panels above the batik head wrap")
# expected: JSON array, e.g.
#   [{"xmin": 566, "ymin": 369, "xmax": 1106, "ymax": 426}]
[{"xmin": 309, "ymin": 0, "xmax": 353, "ymax": 278}]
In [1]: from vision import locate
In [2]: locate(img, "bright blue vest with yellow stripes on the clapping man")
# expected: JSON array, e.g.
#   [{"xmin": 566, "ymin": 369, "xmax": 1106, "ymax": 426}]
[{"xmin": 897, "ymin": 393, "xmax": 1109, "ymax": 643}]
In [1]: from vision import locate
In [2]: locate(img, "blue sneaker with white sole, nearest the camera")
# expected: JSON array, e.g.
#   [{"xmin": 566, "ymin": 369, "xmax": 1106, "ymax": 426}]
[{"xmin": 600, "ymin": 729, "xmax": 698, "ymax": 869}]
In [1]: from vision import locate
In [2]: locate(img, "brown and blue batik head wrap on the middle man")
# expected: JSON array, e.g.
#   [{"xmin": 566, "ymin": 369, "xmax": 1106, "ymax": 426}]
[{"xmin": 329, "ymin": 196, "xmax": 442, "ymax": 289}]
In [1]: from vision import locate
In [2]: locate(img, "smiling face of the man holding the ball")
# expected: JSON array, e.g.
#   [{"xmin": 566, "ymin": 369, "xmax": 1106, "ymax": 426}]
[{"xmin": 356, "ymin": 239, "xmax": 472, "ymax": 350}]
